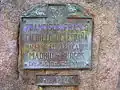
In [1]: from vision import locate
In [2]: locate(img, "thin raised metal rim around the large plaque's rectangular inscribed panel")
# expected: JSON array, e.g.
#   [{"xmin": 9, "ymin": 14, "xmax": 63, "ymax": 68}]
[{"xmin": 19, "ymin": 3, "xmax": 94, "ymax": 70}]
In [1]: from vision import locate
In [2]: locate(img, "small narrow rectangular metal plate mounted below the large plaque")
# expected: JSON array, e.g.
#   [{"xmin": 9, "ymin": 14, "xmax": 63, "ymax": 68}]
[{"xmin": 36, "ymin": 75, "xmax": 80, "ymax": 86}]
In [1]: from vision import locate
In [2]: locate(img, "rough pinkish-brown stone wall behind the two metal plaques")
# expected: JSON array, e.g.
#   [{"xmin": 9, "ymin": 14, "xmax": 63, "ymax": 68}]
[{"xmin": 0, "ymin": 0, "xmax": 120, "ymax": 90}]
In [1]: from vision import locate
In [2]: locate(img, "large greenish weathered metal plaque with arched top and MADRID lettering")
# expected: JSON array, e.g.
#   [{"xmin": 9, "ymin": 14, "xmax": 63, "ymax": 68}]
[{"xmin": 20, "ymin": 4, "xmax": 93, "ymax": 69}]
